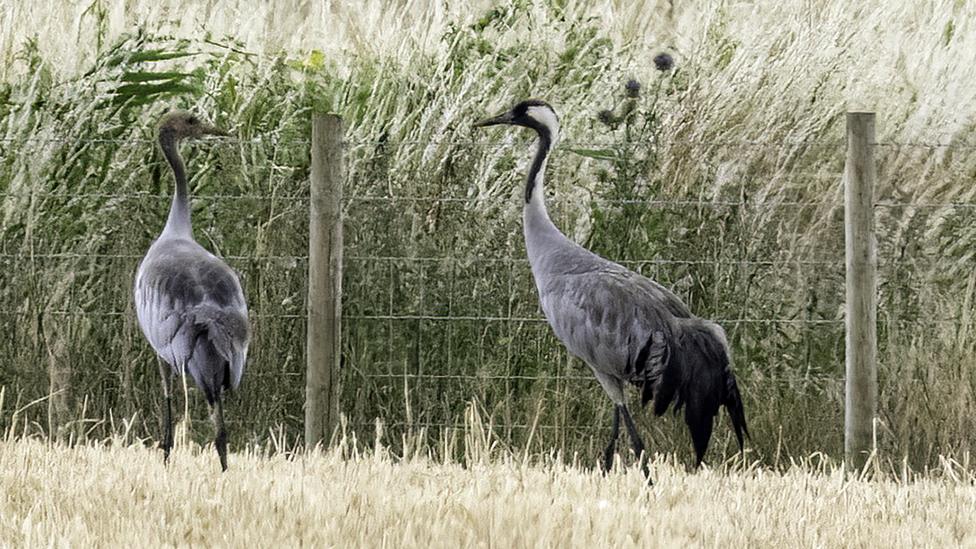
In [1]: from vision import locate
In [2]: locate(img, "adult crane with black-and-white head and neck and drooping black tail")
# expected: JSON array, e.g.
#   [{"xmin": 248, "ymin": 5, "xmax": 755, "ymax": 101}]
[{"xmin": 475, "ymin": 100, "xmax": 749, "ymax": 474}]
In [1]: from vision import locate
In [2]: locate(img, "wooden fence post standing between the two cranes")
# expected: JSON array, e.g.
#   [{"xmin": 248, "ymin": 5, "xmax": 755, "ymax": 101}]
[{"xmin": 305, "ymin": 114, "xmax": 343, "ymax": 448}]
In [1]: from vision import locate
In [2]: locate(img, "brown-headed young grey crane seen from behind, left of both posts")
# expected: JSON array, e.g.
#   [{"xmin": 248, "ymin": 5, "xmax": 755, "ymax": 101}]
[{"xmin": 135, "ymin": 111, "xmax": 249, "ymax": 471}]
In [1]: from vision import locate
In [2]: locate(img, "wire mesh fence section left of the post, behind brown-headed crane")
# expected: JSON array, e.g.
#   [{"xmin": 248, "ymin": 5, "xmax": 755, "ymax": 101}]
[{"xmin": 0, "ymin": 133, "xmax": 308, "ymax": 441}]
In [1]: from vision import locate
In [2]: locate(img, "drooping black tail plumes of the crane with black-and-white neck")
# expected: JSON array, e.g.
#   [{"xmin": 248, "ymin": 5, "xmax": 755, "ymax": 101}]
[{"xmin": 641, "ymin": 318, "xmax": 749, "ymax": 466}]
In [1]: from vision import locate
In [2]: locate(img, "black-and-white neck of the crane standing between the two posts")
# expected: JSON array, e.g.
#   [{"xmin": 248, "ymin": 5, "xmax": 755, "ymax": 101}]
[{"xmin": 522, "ymin": 128, "xmax": 568, "ymax": 266}]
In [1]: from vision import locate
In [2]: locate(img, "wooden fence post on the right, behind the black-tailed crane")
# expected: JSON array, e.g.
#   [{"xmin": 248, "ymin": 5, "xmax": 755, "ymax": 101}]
[{"xmin": 844, "ymin": 112, "xmax": 878, "ymax": 468}]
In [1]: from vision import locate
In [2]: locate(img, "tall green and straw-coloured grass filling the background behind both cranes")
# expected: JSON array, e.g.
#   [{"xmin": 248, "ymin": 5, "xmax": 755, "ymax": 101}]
[{"xmin": 0, "ymin": 0, "xmax": 976, "ymax": 467}]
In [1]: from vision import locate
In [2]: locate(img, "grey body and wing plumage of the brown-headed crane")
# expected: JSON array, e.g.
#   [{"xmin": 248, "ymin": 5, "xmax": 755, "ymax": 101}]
[{"xmin": 135, "ymin": 240, "xmax": 249, "ymax": 393}]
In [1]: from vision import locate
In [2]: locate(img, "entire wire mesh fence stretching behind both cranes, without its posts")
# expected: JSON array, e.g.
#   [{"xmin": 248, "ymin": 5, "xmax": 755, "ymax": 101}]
[{"xmin": 0, "ymin": 132, "xmax": 976, "ymax": 462}]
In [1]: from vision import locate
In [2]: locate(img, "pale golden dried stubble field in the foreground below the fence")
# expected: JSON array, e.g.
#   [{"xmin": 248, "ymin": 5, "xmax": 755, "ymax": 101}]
[{"xmin": 0, "ymin": 432, "xmax": 976, "ymax": 547}]
